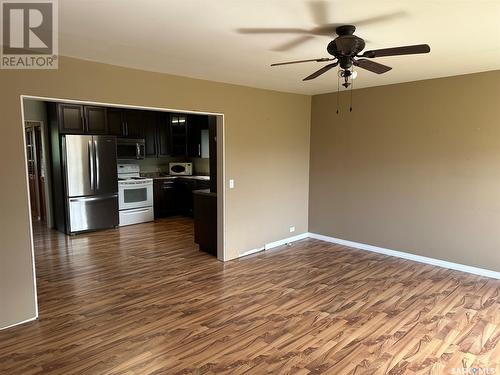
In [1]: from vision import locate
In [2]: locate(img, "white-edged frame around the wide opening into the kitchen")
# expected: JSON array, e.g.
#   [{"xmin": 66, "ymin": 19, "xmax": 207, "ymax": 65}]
[{"xmin": 19, "ymin": 94, "xmax": 228, "ymax": 319}]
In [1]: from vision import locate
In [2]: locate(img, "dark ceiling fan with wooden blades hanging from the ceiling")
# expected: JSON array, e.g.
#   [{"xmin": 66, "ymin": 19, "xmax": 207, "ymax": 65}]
[{"xmin": 271, "ymin": 25, "xmax": 431, "ymax": 88}]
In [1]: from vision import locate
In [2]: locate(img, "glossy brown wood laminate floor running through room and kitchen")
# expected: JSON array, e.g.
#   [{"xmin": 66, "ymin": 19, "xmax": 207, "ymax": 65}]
[{"xmin": 0, "ymin": 218, "xmax": 500, "ymax": 375}]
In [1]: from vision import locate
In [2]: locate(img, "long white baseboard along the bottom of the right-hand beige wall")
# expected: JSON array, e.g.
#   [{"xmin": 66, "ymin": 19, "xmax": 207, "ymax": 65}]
[{"xmin": 309, "ymin": 233, "xmax": 500, "ymax": 279}]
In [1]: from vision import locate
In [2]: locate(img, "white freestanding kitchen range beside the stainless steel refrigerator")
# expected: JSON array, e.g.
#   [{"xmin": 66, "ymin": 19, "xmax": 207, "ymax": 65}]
[{"xmin": 118, "ymin": 164, "xmax": 154, "ymax": 226}]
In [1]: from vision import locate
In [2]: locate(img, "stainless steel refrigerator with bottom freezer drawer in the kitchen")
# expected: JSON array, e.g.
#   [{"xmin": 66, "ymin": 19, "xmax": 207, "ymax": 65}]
[{"xmin": 62, "ymin": 135, "xmax": 118, "ymax": 233}]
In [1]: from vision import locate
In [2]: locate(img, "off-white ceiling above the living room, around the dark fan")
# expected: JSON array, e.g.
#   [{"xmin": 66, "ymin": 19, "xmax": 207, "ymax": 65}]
[{"xmin": 59, "ymin": 0, "xmax": 500, "ymax": 94}]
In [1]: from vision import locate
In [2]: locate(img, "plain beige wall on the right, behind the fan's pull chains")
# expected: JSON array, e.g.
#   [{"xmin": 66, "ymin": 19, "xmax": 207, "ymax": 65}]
[{"xmin": 309, "ymin": 71, "xmax": 500, "ymax": 271}]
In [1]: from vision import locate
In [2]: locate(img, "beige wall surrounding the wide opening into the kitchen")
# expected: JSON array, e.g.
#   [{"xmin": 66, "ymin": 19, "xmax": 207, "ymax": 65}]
[{"xmin": 0, "ymin": 58, "xmax": 311, "ymax": 327}]
